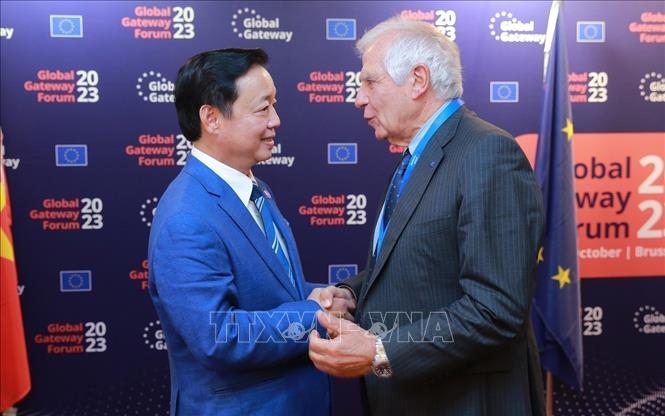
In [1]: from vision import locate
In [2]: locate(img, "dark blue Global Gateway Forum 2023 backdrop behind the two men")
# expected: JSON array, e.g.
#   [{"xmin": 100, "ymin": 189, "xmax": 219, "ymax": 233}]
[{"xmin": 0, "ymin": 1, "xmax": 665, "ymax": 416}]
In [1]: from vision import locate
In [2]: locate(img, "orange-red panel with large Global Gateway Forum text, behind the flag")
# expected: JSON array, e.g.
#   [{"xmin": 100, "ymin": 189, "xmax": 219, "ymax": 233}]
[{"xmin": 517, "ymin": 132, "xmax": 665, "ymax": 278}]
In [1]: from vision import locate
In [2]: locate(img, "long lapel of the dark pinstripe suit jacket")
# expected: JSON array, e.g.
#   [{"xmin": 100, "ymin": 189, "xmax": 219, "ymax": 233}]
[{"xmin": 360, "ymin": 107, "xmax": 466, "ymax": 299}]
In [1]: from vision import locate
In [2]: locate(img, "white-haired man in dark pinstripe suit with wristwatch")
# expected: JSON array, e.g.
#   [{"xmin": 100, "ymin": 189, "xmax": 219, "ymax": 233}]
[{"xmin": 310, "ymin": 17, "xmax": 544, "ymax": 416}]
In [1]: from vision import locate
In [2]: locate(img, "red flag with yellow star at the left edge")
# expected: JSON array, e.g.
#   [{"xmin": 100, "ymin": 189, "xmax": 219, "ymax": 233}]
[{"xmin": 0, "ymin": 129, "xmax": 30, "ymax": 412}]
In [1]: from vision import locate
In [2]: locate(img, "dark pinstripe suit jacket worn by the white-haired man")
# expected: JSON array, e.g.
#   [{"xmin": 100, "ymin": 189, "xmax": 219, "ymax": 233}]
[{"xmin": 344, "ymin": 107, "xmax": 544, "ymax": 416}]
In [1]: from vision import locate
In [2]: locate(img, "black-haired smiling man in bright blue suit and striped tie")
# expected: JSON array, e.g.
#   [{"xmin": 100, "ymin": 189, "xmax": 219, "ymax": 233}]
[{"xmin": 148, "ymin": 49, "xmax": 353, "ymax": 416}]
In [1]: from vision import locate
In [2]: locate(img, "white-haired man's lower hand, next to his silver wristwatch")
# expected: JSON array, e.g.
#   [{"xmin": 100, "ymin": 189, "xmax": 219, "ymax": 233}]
[{"xmin": 309, "ymin": 311, "xmax": 376, "ymax": 377}]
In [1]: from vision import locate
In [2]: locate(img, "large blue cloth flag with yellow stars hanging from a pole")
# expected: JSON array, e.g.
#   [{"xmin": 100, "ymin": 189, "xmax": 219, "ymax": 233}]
[{"xmin": 533, "ymin": 1, "xmax": 582, "ymax": 389}]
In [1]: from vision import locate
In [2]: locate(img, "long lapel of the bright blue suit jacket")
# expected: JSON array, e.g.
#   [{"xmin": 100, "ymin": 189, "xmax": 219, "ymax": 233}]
[{"xmin": 185, "ymin": 156, "xmax": 301, "ymax": 300}]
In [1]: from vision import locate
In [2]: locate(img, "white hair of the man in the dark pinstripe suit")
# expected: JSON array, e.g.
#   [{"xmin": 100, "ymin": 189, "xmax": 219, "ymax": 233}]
[{"xmin": 356, "ymin": 16, "xmax": 463, "ymax": 101}]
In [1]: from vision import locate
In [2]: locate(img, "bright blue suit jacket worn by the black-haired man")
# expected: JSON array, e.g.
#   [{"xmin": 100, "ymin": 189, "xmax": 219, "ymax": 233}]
[{"xmin": 148, "ymin": 157, "xmax": 330, "ymax": 416}]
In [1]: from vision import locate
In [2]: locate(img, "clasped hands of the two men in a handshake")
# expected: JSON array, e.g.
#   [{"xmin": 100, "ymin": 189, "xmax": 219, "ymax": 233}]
[{"xmin": 307, "ymin": 286, "xmax": 376, "ymax": 377}]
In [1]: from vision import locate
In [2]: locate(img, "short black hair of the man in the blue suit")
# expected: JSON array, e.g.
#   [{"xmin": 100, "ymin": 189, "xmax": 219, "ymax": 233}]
[{"xmin": 174, "ymin": 48, "xmax": 268, "ymax": 142}]
